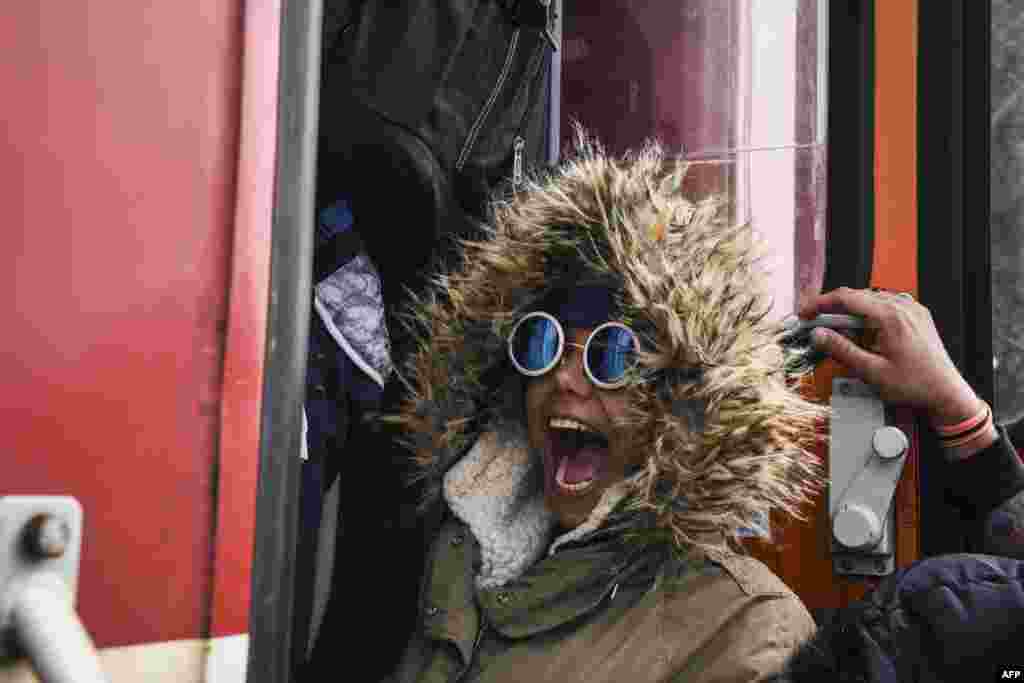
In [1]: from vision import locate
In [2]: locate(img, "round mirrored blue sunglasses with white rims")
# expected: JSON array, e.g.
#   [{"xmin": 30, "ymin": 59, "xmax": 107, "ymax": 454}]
[{"xmin": 508, "ymin": 311, "xmax": 638, "ymax": 389}]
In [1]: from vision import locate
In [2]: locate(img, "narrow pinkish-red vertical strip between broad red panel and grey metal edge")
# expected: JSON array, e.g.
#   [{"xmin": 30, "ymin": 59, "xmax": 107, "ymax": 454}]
[{"xmin": 210, "ymin": 0, "xmax": 281, "ymax": 636}]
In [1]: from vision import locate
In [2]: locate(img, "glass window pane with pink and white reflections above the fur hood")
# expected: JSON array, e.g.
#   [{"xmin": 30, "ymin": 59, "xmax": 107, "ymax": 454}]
[{"xmin": 561, "ymin": 0, "xmax": 827, "ymax": 317}]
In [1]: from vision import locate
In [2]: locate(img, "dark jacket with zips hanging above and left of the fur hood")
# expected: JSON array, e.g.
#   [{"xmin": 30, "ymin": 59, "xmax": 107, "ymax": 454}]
[{"xmin": 318, "ymin": 0, "xmax": 557, "ymax": 331}]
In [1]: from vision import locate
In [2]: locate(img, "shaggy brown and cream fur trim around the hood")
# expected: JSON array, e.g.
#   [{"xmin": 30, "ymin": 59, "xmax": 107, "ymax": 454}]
[{"xmin": 387, "ymin": 129, "xmax": 827, "ymax": 565}]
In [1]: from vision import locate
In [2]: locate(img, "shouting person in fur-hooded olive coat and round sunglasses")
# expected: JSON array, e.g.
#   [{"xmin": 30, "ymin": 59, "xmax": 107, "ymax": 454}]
[{"xmin": 385, "ymin": 132, "xmax": 1024, "ymax": 683}]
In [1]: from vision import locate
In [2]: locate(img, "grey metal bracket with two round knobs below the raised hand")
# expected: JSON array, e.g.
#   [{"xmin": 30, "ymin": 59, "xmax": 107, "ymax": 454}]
[{"xmin": 828, "ymin": 378, "xmax": 909, "ymax": 575}]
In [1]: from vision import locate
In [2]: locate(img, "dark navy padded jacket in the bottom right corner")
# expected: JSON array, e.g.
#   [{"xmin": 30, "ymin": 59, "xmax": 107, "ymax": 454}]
[{"xmin": 767, "ymin": 555, "xmax": 1024, "ymax": 683}]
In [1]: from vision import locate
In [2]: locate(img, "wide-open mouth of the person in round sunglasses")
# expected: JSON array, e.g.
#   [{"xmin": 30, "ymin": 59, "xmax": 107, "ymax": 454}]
[{"xmin": 545, "ymin": 417, "xmax": 608, "ymax": 496}]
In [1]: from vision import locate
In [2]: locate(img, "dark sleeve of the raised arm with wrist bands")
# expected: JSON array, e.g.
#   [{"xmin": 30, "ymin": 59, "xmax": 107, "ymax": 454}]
[{"xmin": 949, "ymin": 427, "xmax": 1024, "ymax": 559}]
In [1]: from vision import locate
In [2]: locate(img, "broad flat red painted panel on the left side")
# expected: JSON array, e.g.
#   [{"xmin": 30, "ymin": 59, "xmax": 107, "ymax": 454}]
[{"xmin": 0, "ymin": 0, "xmax": 253, "ymax": 647}]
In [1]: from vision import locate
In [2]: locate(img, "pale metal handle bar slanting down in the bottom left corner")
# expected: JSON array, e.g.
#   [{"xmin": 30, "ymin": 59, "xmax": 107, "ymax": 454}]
[{"xmin": 3, "ymin": 572, "xmax": 106, "ymax": 683}]
